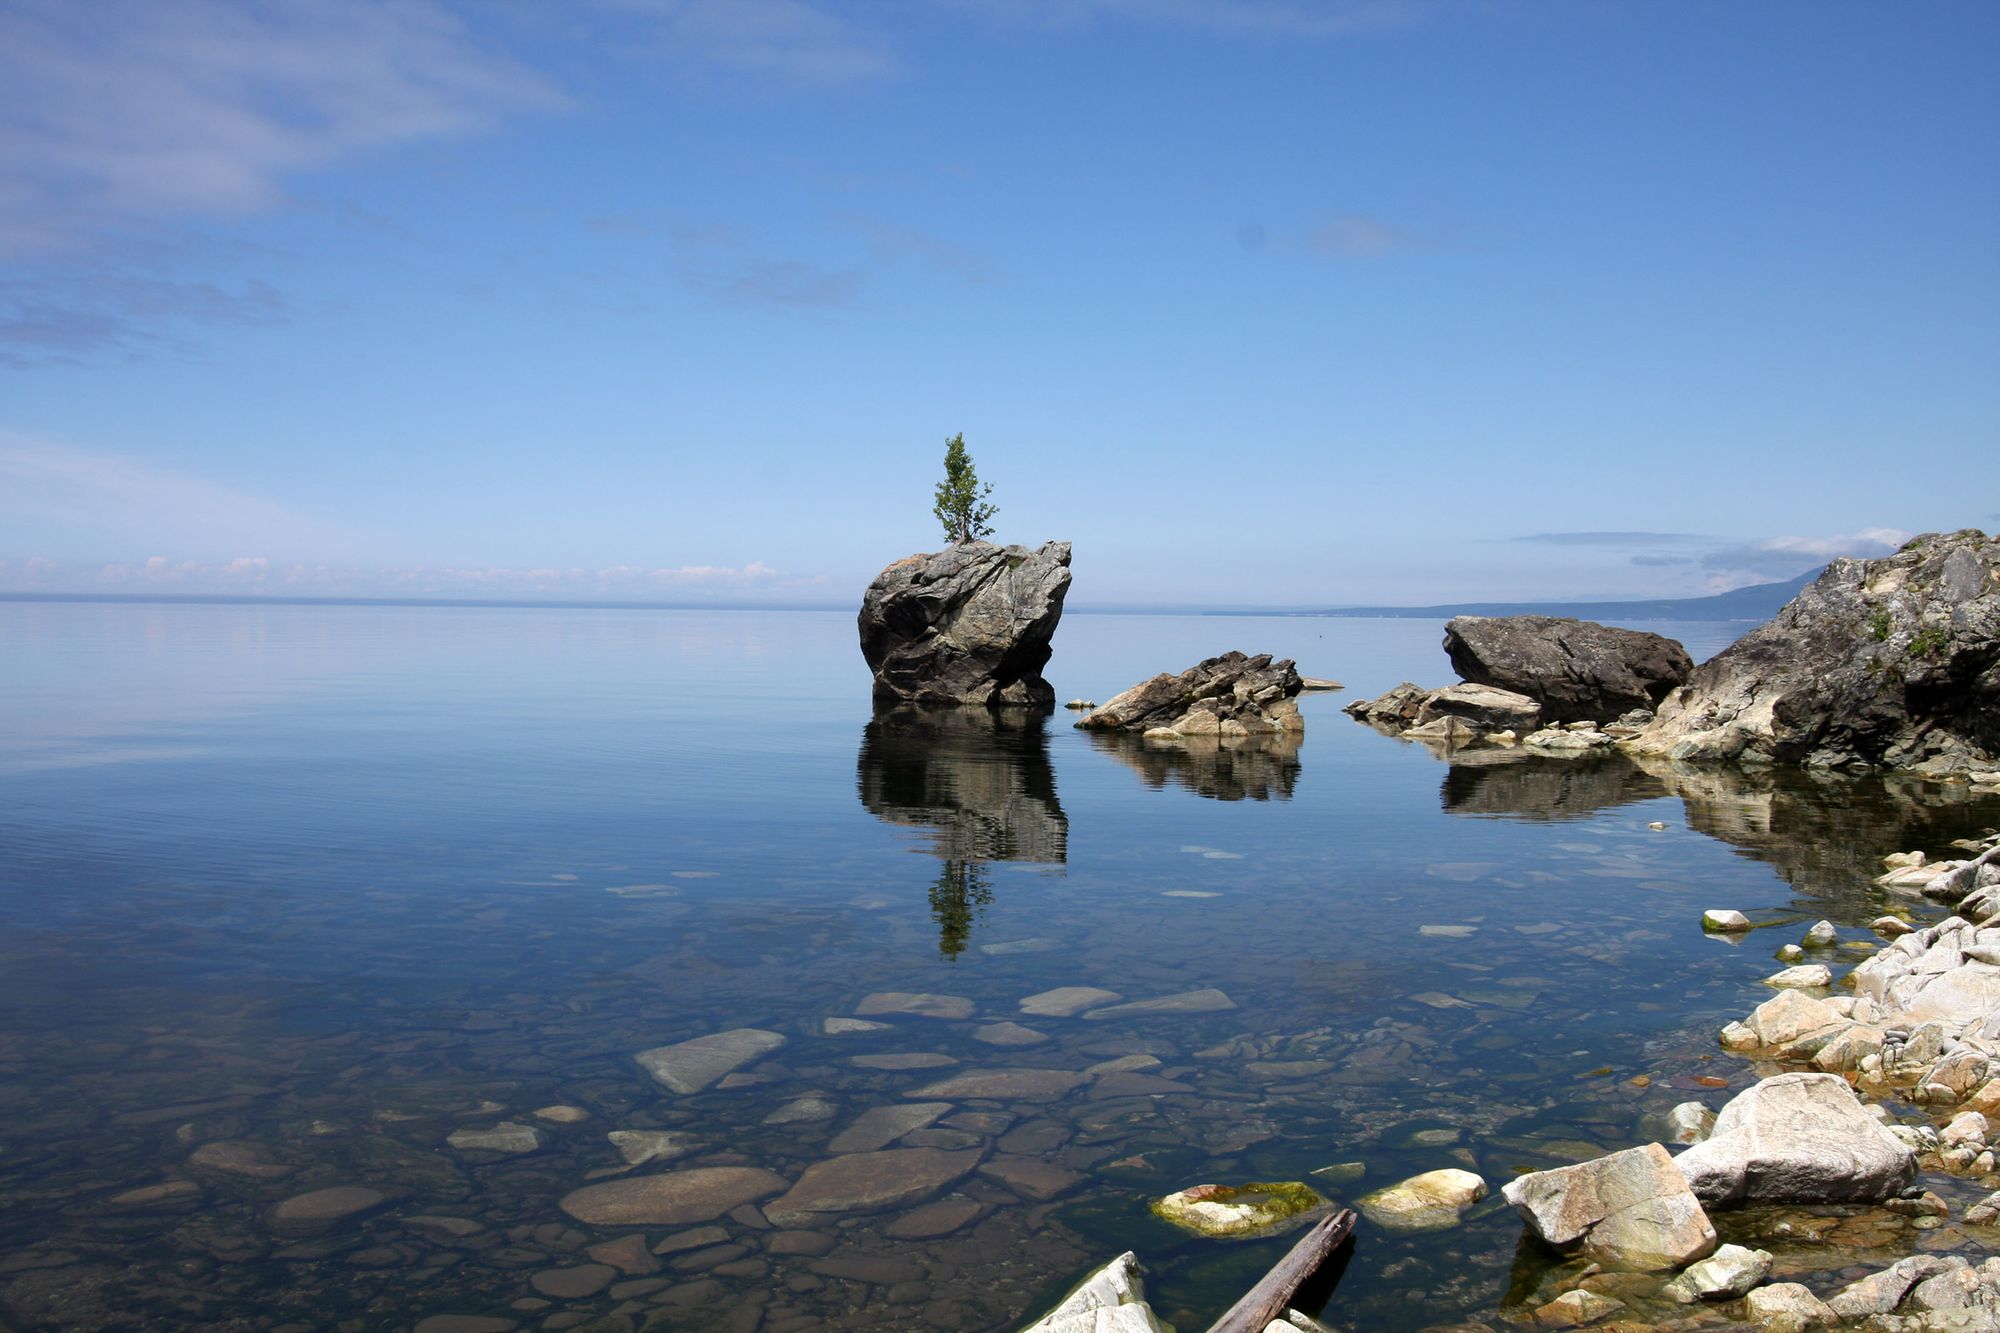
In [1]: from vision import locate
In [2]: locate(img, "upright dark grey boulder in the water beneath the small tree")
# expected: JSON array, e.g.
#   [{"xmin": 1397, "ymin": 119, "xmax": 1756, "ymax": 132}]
[{"xmin": 858, "ymin": 542, "xmax": 1070, "ymax": 709}]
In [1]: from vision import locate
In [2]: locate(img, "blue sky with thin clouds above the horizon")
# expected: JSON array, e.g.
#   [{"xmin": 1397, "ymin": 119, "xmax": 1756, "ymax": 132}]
[{"xmin": 0, "ymin": 0, "xmax": 2000, "ymax": 606}]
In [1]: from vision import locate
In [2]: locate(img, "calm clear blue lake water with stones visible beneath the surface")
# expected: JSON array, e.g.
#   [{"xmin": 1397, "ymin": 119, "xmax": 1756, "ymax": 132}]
[{"xmin": 0, "ymin": 604, "xmax": 2000, "ymax": 1333}]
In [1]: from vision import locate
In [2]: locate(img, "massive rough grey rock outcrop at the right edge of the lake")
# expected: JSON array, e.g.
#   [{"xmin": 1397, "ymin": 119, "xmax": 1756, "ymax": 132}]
[{"xmin": 1632, "ymin": 528, "xmax": 2000, "ymax": 775}]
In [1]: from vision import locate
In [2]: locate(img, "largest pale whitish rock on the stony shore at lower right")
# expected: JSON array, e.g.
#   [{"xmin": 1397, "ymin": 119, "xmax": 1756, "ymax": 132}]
[{"xmin": 1674, "ymin": 1073, "xmax": 1916, "ymax": 1207}]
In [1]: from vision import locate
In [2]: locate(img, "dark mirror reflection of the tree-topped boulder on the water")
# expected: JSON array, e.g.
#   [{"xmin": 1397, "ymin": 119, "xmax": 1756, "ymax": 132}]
[{"xmin": 856, "ymin": 707, "xmax": 1070, "ymax": 959}]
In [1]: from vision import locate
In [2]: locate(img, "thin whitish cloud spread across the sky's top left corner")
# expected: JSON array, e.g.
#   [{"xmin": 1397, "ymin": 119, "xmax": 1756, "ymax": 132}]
[{"xmin": 0, "ymin": 0, "xmax": 560, "ymax": 256}]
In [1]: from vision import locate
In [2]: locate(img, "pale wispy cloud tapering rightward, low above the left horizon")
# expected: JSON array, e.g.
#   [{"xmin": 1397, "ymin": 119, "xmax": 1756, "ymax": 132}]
[{"xmin": 0, "ymin": 430, "xmax": 364, "ymax": 556}]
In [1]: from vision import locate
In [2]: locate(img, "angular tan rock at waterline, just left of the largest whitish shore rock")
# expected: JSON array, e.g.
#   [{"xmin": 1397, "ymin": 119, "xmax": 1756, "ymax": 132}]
[{"xmin": 1502, "ymin": 1143, "xmax": 1716, "ymax": 1273}]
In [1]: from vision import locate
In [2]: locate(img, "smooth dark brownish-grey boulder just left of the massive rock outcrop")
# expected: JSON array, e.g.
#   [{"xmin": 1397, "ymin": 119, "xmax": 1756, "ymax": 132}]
[{"xmin": 1444, "ymin": 616, "xmax": 1694, "ymax": 723}]
